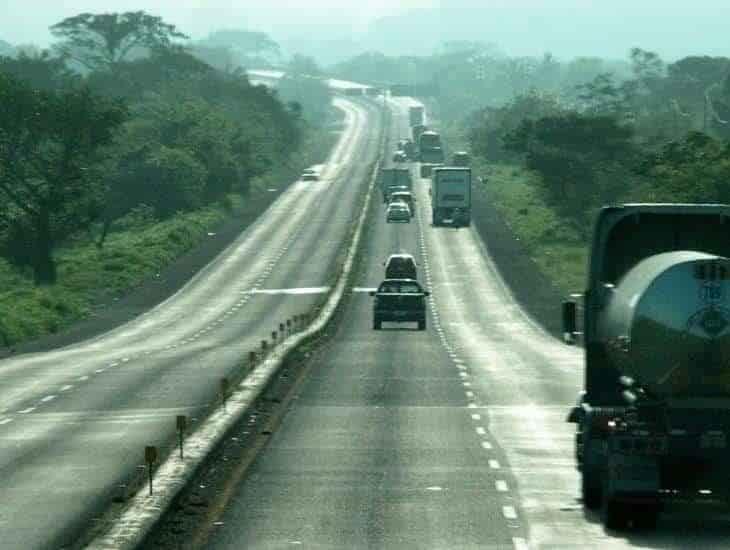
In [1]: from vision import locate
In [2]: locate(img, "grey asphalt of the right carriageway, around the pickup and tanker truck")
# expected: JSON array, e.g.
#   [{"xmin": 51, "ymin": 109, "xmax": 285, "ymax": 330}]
[{"xmin": 196, "ymin": 100, "xmax": 730, "ymax": 550}]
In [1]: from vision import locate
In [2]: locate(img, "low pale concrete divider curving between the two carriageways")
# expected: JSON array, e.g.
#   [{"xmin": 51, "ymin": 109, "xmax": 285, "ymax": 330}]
[{"xmin": 86, "ymin": 101, "xmax": 386, "ymax": 550}]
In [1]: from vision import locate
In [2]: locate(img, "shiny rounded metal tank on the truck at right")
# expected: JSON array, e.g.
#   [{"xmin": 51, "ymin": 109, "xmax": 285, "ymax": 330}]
[{"xmin": 596, "ymin": 251, "xmax": 730, "ymax": 398}]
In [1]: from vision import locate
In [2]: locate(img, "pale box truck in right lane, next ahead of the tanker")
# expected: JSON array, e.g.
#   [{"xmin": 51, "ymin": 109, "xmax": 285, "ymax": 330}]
[{"xmin": 431, "ymin": 166, "xmax": 471, "ymax": 227}]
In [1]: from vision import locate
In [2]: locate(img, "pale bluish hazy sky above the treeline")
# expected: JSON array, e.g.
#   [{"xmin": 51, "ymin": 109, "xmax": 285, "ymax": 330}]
[{"xmin": 0, "ymin": 0, "xmax": 730, "ymax": 63}]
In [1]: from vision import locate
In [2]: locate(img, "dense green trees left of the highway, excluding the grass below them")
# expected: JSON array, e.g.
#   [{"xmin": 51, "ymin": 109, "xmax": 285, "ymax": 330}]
[{"xmin": 0, "ymin": 12, "xmax": 308, "ymax": 284}]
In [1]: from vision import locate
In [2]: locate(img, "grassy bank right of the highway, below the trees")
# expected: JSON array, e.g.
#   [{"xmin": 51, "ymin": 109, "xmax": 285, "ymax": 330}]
[{"xmin": 443, "ymin": 123, "xmax": 588, "ymax": 295}]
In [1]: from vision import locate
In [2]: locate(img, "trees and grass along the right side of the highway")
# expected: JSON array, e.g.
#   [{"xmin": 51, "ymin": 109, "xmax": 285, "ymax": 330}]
[{"xmin": 334, "ymin": 42, "xmax": 730, "ymax": 293}]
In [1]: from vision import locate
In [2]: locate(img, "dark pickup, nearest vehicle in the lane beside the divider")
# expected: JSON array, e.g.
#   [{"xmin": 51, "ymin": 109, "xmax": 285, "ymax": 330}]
[{"xmin": 370, "ymin": 279, "xmax": 430, "ymax": 330}]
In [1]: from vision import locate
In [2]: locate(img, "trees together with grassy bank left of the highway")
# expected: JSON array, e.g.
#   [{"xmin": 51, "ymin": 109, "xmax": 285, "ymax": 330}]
[{"xmin": 0, "ymin": 12, "xmax": 336, "ymax": 346}]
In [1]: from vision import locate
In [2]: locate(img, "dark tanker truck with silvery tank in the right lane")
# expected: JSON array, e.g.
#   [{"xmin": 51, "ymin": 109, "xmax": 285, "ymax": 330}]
[{"xmin": 562, "ymin": 204, "xmax": 730, "ymax": 528}]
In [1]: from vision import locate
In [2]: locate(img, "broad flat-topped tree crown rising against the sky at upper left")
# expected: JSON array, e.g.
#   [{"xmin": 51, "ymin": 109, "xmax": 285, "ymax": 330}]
[{"xmin": 51, "ymin": 11, "xmax": 188, "ymax": 70}]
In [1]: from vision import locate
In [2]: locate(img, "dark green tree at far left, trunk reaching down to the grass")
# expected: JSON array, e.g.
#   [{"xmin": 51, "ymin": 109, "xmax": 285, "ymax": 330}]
[{"xmin": 0, "ymin": 75, "xmax": 126, "ymax": 284}]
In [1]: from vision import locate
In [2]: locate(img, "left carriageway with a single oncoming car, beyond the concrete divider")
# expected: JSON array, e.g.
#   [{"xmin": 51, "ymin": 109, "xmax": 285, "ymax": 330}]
[{"xmin": 0, "ymin": 99, "xmax": 380, "ymax": 550}]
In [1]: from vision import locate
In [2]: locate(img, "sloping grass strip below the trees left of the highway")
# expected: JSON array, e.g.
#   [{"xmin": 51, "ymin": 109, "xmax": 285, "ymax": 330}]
[{"xmin": 0, "ymin": 118, "xmax": 340, "ymax": 346}]
